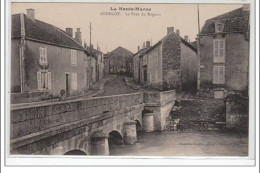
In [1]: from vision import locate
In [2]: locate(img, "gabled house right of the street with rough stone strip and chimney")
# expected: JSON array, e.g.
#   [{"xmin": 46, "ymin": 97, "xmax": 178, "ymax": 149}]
[{"xmin": 139, "ymin": 27, "xmax": 197, "ymax": 91}]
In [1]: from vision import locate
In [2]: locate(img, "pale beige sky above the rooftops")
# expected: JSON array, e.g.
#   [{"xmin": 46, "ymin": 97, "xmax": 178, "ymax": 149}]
[{"xmin": 11, "ymin": 3, "xmax": 242, "ymax": 53}]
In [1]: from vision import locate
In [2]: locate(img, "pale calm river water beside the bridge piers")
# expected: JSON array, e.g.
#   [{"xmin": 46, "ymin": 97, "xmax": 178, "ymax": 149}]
[{"xmin": 110, "ymin": 131, "xmax": 248, "ymax": 156}]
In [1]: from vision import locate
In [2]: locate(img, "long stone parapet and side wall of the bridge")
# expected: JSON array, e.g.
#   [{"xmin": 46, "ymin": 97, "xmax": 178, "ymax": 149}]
[{"xmin": 10, "ymin": 93, "xmax": 144, "ymax": 154}]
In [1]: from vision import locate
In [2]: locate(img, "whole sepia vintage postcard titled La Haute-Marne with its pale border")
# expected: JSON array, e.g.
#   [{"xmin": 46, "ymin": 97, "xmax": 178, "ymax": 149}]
[{"xmin": 6, "ymin": 0, "xmax": 255, "ymax": 165}]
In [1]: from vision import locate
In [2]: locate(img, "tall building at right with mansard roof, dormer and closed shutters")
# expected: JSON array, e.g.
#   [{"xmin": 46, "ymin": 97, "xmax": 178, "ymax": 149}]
[{"xmin": 200, "ymin": 5, "xmax": 250, "ymax": 98}]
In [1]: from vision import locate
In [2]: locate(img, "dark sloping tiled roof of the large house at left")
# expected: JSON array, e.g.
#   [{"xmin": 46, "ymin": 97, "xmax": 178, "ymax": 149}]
[{"xmin": 12, "ymin": 14, "xmax": 84, "ymax": 50}]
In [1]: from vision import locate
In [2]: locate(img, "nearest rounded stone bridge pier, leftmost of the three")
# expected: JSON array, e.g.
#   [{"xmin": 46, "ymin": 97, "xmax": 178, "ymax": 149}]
[{"xmin": 90, "ymin": 132, "xmax": 109, "ymax": 155}]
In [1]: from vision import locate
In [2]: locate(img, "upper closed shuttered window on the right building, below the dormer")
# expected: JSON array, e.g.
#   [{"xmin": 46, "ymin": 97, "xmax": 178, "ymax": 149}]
[{"xmin": 213, "ymin": 39, "xmax": 225, "ymax": 62}]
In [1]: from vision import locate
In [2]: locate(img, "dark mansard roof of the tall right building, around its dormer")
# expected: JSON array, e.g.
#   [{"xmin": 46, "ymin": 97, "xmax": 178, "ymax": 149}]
[{"xmin": 201, "ymin": 8, "xmax": 249, "ymax": 34}]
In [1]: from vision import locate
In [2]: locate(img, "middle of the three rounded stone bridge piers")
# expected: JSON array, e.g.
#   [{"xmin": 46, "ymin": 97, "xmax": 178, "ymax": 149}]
[{"xmin": 124, "ymin": 120, "xmax": 137, "ymax": 144}]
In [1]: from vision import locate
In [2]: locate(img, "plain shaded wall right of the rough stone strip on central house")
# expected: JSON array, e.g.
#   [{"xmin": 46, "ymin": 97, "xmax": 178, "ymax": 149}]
[{"xmin": 181, "ymin": 43, "xmax": 197, "ymax": 91}]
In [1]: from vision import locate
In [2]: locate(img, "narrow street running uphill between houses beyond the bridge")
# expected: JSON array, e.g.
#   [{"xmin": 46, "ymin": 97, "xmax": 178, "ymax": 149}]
[{"xmin": 98, "ymin": 75, "xmax": 138, "ymax": 96}]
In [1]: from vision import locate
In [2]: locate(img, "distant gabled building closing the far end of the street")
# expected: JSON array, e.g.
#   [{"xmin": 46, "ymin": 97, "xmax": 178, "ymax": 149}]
[{"xmin": 105, "ymin": 47, "xmax": 133, "ymax": 75}]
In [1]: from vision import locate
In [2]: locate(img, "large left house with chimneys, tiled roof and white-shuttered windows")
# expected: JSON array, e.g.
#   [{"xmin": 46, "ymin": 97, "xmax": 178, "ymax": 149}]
[{"xmin": 11, "ymin": 9, "xmax": 96, "ymax": 102}]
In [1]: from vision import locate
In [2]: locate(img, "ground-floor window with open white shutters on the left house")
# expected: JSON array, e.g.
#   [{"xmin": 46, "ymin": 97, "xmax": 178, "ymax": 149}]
[{"xmin": 37, "ymin": 70, "xmax": 51, "ymax": 90}]
